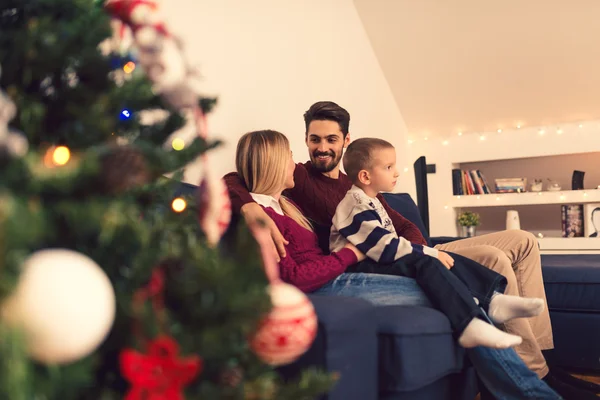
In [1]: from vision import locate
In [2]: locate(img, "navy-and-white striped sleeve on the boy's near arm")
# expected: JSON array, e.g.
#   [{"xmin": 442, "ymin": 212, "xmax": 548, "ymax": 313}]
[{"xmin": 334, "ymin": 204, "xmax": 438, "ymax": 263}]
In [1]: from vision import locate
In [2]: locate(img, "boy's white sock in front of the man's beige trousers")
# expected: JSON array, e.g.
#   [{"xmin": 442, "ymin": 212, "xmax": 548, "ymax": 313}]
[{"xmin": 488, "ymin": 293, "xmax": 545, "ymax": 324}]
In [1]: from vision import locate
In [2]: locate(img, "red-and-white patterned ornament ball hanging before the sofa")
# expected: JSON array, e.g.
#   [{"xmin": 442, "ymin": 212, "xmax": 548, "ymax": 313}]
[{"xmin": 250, "ymin": 283, "xmax": 317, "ymax": 366}]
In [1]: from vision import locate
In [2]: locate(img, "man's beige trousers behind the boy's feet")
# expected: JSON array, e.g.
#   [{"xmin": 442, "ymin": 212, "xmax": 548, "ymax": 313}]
[{"xmin": 436, "ymin": 230, "xmax": 554, "ymax": 378}]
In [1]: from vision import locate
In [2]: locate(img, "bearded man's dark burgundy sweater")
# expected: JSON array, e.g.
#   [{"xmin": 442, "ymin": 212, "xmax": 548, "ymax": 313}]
[{"xmin": 225, "ymin": 161, "xmax": 427, "ymax": 253}]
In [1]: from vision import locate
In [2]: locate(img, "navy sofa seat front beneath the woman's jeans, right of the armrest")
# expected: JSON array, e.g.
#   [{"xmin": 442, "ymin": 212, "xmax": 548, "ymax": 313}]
[{"xmin": 374, "ymin": 306, "xmax": 465, "ymax": 393}]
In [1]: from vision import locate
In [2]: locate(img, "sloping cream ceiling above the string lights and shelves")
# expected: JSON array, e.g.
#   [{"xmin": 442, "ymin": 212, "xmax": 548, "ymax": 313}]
[{"xmin": 354, "ymin": 0, "xmax": 600, "ymax": 137}]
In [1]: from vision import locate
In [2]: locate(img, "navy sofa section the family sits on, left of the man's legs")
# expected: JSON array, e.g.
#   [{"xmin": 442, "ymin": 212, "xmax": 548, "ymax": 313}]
[{"xmin": 281, "ymin": 193, "xmax": 478, "ymax": 400}]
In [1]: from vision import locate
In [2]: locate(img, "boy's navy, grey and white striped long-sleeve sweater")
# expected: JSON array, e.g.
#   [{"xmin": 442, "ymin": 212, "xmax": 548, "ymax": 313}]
[{"xmin": 329, "ymin": 186, "xmax": 438, "ymax": 263}]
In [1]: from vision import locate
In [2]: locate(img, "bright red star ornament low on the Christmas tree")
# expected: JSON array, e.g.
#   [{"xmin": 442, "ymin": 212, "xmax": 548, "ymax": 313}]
[{"xmin": 120, "ymin": 336, "xmax": 202, "ymax": 400}]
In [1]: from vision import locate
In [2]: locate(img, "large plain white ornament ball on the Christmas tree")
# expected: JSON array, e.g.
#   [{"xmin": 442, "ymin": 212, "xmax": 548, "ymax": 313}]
[{"xmin": 0, "ymin": 249, "xmax": 115, "ymax": 364}]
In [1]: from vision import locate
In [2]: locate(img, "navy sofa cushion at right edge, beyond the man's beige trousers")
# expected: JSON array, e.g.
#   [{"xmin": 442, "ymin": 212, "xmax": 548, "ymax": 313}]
[{"xmin": 542, "ymin": 254, "xmax": 600, "ymax": 312}]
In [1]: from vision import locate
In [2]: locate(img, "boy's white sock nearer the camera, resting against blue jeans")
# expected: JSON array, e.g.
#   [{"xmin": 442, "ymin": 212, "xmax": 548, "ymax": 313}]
[{"xmin": 458, "ymin": 318, "xmax": 523, "ymax": 349}]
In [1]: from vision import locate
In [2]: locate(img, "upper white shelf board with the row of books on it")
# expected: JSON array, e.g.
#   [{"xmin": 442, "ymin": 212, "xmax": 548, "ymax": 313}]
[{"xmin": 452, "ymin": 189, "xmax": 600, "ymax": 208}]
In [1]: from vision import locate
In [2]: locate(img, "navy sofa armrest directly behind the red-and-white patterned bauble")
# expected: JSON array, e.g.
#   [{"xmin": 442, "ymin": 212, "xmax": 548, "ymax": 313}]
[{"xmin": 279, "ymin": 295, "xmax": 378, "ymax": 400}]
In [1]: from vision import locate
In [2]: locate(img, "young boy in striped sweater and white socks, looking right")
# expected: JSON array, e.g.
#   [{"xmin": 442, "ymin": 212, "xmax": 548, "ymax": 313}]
[{"xmin": 330, "ymin": 138, "xmax": 544, "ymax": 348}]
